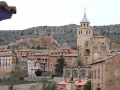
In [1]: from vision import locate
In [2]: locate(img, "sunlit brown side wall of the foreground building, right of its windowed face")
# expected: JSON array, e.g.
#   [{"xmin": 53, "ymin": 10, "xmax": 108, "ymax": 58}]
[{"xmin": 104, "ymin": 55, "xmax": 120, "ymax": 90}]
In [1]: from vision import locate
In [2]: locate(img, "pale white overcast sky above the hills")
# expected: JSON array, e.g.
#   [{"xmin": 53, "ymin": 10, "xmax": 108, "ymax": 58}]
[{"xmin": 0, "ymin": 0, "xmax": 120, "ymax": 30}]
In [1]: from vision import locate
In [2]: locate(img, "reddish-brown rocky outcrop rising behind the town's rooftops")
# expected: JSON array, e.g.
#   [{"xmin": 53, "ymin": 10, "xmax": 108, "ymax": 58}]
[{"xmin": 0, "ymin": 36, "xmax": 59, "ymax": 49}]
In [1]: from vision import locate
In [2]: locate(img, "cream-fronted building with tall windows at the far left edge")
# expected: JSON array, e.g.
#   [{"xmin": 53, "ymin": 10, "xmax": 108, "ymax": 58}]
[{"xmin": 0, "ymin": 50, "xmax": 16, "ymax": 79}]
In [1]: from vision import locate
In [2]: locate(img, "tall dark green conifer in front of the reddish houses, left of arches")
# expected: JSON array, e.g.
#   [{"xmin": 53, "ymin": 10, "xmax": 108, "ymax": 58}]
[{"xmin": 55, "ymin": 56, "xmax": 67, "ymax": 76}]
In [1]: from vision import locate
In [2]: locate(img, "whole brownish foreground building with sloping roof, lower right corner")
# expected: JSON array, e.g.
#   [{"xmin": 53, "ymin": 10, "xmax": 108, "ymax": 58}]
[{"xmin": 91, "ymin": 53, "xmax": 120, "ymax": 90}]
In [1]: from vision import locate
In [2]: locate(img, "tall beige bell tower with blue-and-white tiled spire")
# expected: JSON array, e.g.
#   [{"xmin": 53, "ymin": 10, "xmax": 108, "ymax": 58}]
[{"xmin": 77, "ymin": 8, "xmax": 93, "ymax": 66}]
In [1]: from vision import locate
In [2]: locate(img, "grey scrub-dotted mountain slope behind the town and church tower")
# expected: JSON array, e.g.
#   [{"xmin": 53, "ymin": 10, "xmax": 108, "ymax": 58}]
[{"xmin": 0, "ymin": 24, "xmax": 120, "ymax": 47}]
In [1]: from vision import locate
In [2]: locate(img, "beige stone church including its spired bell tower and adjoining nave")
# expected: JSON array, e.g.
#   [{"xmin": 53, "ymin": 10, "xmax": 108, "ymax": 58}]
[{"xmin": 77, "ymin": 9, "xmax": 120, "ymax": 66}]
